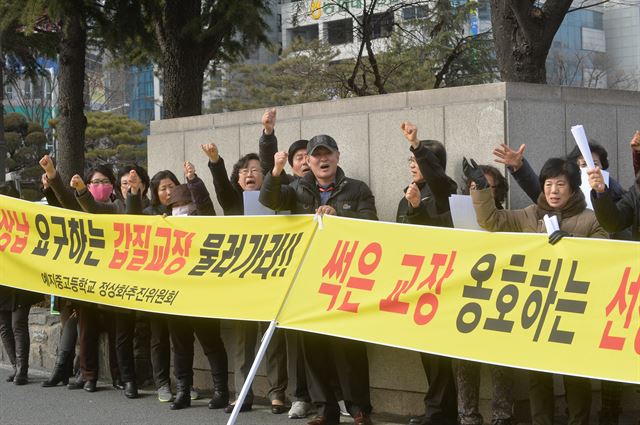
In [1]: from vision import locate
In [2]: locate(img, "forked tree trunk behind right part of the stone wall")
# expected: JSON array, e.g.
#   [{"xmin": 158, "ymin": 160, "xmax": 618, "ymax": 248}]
[{"xmin": 491, "ymin": 0, "xmax": 562, "ymax": 84}]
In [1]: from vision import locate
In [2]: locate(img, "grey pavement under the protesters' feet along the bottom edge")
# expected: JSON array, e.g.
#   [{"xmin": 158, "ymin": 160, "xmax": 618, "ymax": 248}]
[{"xmin": 0, "ymin": 366, "xmax": 408, "ymax": 425}]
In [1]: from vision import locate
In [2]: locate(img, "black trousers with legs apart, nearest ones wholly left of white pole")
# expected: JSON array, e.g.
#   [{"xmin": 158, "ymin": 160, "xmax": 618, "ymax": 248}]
[{"xmin": 168, "ymin": 316, "xmax": 229, "ymax": 391}]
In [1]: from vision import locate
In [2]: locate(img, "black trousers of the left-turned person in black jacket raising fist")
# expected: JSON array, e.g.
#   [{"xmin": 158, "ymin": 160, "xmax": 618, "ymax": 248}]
[{"xmin": 420, "ymin": 353, "xmax": 458, "ymax": 425}]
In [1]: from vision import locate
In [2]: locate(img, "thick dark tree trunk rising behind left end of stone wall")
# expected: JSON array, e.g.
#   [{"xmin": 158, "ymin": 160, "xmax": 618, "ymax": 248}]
[{"xmin": 162, "ymin": 44, "xmax": 207, "ymax": 118}]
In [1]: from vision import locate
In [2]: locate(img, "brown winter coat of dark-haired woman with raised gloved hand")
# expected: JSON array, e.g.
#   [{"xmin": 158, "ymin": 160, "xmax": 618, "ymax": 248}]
[{"xmin": 471, "ymin": 188, "xmax": 609, "ymax": 239}]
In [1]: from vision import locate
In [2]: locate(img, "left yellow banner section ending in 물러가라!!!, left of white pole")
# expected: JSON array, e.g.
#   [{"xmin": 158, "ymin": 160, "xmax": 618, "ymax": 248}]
[{"xmin": 0, "ymin": 196, "xmax": 315, "ymax": 321}]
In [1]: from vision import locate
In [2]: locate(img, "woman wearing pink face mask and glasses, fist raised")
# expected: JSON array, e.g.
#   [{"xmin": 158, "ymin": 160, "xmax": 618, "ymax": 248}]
[{"xmin": 70, "ymin": 165, "xmax": 138, "ymax": 398}]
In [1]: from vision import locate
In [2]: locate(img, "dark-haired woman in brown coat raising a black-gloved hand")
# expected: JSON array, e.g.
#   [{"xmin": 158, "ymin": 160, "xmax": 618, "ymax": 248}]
[{"xmin": 463, "ymin": 158, "xmax": 608, "ymax": 425}]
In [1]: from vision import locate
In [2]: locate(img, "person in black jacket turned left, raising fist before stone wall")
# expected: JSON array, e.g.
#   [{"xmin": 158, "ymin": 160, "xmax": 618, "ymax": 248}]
[{"xmin": 396, "ymin": 122, "xmax": 458, "ymax": 425}]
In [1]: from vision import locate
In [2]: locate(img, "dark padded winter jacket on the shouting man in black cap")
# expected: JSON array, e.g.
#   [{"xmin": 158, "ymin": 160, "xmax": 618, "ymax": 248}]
[{"xmin": 260, "ymin": 167, "xmax": 378, "ymax": 220}]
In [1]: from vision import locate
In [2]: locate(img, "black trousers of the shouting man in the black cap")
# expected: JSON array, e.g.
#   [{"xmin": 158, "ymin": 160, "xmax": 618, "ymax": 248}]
[{"xmin": 301, "ymin": 333, "xmax": 371, "ymax": 422}]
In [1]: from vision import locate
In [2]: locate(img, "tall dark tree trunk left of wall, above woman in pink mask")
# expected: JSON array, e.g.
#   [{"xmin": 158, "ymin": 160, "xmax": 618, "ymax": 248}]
[{"xmin": 56, "ymin": 10, "xmax": 87, "ymax": 181}]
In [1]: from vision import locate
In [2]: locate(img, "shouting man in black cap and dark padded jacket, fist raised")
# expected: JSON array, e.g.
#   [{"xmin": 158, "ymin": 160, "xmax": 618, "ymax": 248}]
[{"xmin": 260, "ymin": 135, "xmax": 378, "ymax": 425}]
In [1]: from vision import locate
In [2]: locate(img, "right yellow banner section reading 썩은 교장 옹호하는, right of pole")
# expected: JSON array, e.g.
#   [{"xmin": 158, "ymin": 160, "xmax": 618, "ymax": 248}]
[{"xmin": 278, "ymin": 217, "xmax": 640, "ymax": 383}]
